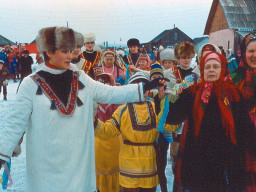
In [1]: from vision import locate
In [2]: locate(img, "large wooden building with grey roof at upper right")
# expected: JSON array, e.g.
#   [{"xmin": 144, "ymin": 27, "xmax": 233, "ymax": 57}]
[{"xmin": 204, "ymin": 0, "xmax": 256, "ymax": 52}]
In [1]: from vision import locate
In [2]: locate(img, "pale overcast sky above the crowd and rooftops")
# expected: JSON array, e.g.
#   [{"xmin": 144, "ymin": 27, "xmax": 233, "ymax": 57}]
[{"xmin": 0, "ymin": 0, "xmax": 213, "ymax": 44}]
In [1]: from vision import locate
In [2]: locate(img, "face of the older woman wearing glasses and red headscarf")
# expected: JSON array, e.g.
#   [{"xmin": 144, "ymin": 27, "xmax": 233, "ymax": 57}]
[{"xmin": 204, "ymin": 59, "xmax": 221, "ymax": 82}]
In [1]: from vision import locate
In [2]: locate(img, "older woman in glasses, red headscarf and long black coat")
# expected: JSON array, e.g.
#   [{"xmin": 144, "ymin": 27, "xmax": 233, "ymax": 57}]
[{"xmin": 156, "ymin": 52, "xmax": 256, "ymax": 192}]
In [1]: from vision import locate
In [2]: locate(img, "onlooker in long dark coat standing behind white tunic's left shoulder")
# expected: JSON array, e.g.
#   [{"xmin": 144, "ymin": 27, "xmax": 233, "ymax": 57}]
[{"xmin": 17, "ymin": 50, "xmax": 33, "ymax": 91}]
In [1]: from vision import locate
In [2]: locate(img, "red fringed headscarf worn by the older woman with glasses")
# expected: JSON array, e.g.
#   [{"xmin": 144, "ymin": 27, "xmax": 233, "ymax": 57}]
[{"xmin": 190, "ymin": 52, "xmax": 240, "ymax": 144}]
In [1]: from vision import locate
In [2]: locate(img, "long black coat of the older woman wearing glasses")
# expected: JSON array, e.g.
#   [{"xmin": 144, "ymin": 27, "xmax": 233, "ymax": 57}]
[{"xmin": 156, "ymin": 89, "xmax": 256, "ymax": 192}]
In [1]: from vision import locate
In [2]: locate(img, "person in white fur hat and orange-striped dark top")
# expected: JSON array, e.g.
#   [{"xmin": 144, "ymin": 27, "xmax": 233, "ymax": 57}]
[{"xmin": 81, "ymin": 33, "xmax": 101, "ymax": 79}]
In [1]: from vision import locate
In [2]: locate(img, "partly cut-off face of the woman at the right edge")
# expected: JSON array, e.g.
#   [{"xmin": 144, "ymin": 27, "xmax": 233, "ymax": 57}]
[{"xmin": 245, "ymin": 40, "xmax": 256, "ymax": 69}]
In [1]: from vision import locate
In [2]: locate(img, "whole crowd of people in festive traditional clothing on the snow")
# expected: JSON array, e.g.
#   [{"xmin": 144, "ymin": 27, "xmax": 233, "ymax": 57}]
[{"xmin": 0, "ymin": 27, "xmax": 256, "ymax": 192}]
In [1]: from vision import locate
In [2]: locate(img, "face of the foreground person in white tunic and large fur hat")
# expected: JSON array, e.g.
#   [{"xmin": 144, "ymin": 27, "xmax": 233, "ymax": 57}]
[{"xmin": 46, "ymin": 50, "xmax": 72, "ymax": 69}]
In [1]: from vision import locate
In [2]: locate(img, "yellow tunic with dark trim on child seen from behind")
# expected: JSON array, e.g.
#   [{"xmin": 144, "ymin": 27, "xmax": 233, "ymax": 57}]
[{"xmin": 94, "ymin": 102, "xmax": 179, "ymax": 188}]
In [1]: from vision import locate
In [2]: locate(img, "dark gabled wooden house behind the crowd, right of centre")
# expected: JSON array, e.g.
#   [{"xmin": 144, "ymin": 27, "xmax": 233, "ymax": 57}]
[{"xmin": 142, "ymin": 27, "xmax": 195, "ymax": 51}]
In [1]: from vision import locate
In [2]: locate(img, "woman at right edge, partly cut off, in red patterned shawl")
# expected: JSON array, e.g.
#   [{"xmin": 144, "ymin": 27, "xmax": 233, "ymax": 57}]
[{"xmin": 231, "ymin": 32, "xmax": 256, "ymax": 192}]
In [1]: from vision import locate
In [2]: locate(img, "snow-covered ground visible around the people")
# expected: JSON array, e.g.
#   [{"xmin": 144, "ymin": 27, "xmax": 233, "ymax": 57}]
[{"xmin": 0, "ymin": 80, "xmax": 173, "ymax": 192}]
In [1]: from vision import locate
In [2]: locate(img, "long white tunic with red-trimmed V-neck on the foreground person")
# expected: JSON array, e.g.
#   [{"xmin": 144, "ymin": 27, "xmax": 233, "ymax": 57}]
[{"xmin": 0, "ymin": 65, "xmax": 143, "ymax": 192}]
